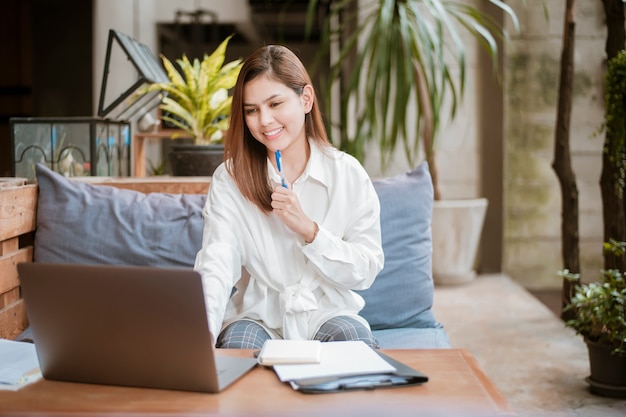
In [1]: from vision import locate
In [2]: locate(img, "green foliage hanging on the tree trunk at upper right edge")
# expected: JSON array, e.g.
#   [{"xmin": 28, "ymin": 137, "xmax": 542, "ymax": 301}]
[{"xmin": 601, "ymin": 51, "xmax": 626, "ymax": 199}]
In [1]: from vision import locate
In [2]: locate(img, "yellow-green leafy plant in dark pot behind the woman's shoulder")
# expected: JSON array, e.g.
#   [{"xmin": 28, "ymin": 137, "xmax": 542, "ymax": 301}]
[{"xmin": 138, "ymin": 35, "xmax": 242, "ymax": 176}]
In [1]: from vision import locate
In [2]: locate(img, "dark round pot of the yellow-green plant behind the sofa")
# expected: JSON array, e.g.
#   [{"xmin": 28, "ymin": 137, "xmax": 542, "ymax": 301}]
[{"xmin": 169, "ymin": 144, "xmax": 224, "ymax": 177}]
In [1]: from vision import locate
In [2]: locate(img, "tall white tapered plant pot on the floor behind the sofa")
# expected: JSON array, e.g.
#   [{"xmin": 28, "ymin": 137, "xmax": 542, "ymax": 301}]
[{"xmin": 432, "ymin": 198, "xmax": 488, "ymax": 285}]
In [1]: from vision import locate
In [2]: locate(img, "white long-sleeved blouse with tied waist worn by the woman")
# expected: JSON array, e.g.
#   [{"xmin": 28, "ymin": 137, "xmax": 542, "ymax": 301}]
[{"xmin": 194, "ymin": 142, "xmax": 384, "ymax": 340}]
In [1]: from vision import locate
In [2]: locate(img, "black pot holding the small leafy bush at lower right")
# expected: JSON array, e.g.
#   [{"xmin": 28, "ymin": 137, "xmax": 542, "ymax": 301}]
[{"xmin": 585, "ymin": 339, "xmax": 626, "ymax": 398}]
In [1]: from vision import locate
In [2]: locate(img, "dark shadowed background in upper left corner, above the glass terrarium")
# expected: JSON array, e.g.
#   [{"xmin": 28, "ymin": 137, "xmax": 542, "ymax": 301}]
[{"xmin": 0, "ymin": 0, "xmax": 93, "ymax": 176}]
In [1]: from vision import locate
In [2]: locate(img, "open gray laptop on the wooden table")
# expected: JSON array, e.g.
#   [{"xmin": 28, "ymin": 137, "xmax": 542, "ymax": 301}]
[{"xmin": 17, "ymin": 262, "xmax": 257, "ymax": 393}]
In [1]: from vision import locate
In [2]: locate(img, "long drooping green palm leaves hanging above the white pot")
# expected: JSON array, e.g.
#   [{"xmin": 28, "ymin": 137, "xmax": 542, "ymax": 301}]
[{"xmin": 307, "ymin": 0, "xmax": 518, "ymax": 199}]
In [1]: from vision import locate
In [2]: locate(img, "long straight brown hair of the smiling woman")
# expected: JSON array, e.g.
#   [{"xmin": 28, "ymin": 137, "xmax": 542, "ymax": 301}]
[{"xmin": 224, "ymin": 45, "xmax": 329, "ymax": 213}]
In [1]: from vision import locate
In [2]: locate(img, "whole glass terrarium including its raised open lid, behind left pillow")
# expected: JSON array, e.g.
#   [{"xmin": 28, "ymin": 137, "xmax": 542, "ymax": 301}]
[{"xmin": 9, "ymin": 30, "xmax": 168, "ymax": 178}]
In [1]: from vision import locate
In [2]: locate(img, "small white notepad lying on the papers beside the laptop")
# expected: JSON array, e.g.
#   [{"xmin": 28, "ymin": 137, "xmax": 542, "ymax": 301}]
[{"xmin": 258, "ymin": 339, "xmax": 322, "ymax": 366}]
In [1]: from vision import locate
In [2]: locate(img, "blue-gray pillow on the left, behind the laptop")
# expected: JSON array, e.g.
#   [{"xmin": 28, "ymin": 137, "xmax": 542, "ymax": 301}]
[{"xmin": 34, "ymin": 164, "xmax": 206, "ymax": 267}]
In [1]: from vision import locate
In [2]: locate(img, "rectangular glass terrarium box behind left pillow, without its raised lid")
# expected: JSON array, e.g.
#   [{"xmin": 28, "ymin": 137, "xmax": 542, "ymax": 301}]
[{"xmin": 9, "ymin": 117, "xmax": 131, "ymax": 178}]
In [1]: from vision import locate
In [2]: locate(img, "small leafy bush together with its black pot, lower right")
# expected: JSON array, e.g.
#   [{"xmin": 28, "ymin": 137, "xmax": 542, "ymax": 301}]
[{"xmin": 560, "ymin": 239, "xmax": 626, "ymax": 398}]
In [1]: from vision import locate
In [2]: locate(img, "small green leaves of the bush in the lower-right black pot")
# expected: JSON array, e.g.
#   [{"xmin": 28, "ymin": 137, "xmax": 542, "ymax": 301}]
[{"xmin": 560, "ymin": 240, "xmax": 626, "ymax": 354}]
